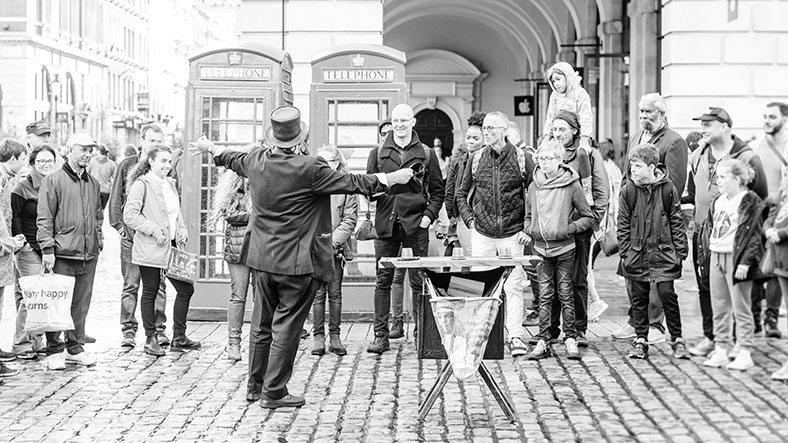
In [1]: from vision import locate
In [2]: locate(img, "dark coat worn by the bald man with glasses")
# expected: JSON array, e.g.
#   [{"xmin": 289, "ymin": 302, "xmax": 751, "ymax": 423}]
[{"xmin": 367, "ymin": 131, "xmax": 444, "ymax": 239}]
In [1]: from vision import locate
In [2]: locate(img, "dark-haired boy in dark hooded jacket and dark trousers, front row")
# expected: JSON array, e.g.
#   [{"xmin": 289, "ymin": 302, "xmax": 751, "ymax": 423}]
[{"xmin": 618, "ymin": 143, "xmax": 689, "ymax": 359}]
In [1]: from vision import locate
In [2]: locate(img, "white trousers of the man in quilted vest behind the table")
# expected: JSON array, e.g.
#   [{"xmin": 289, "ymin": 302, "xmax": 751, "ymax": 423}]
[{"xmin": 471, "ymin": 230, "xmax": 528, "ymax": 340}]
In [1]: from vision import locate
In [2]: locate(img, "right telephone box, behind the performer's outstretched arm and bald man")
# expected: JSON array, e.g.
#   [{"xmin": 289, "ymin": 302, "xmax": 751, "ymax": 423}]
[{"xmin": 309, "ymin": 44, "xmax": 408, "ymax": 319}]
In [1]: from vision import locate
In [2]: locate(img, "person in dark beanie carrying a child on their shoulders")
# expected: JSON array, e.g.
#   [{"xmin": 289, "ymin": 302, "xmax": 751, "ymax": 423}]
[{"xmin": 551, "ymin": 111, "xmax": 610, "ymax": 347}]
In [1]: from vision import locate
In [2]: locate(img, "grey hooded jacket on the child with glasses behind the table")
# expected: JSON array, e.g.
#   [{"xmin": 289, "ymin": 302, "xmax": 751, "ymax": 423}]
[{"xmin": 525, "ymin": 164, "xmax": 593, "ymax": 257}]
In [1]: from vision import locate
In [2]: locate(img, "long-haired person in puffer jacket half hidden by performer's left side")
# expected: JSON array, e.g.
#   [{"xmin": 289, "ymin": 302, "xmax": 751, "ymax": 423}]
[{"xmin": 208, "ymin": 147, "xmax": 252, "ymax": 361}]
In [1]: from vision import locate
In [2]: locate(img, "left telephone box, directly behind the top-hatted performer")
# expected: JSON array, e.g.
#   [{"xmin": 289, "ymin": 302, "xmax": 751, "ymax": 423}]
[{"xmin": 180, "ymin": 42, "xmax": 293, "ymax": 320}]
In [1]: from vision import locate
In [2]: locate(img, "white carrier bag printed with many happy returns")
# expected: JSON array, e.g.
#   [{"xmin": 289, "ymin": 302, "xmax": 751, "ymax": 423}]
[{"xmin": 19, "ymin": 272, "xmax": 74, "ymax": 334}]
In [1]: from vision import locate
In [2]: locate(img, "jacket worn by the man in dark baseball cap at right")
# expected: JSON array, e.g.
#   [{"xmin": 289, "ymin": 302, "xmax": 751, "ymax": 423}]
[{"xmin": 687, "ymin": 135, "xmax": 769, "ymax": 226}]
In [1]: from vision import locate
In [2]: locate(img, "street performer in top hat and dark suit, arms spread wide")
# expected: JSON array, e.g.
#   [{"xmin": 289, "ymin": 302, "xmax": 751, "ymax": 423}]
[{"xmin": 197, "ymin": 106, "xmax": 413, "ymax": 409}]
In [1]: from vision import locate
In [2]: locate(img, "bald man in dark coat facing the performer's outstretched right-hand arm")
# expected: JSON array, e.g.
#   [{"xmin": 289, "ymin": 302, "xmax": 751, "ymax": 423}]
[{"xmin": 367, "ymin": 104, "xmax": 444, "ymax": 354}]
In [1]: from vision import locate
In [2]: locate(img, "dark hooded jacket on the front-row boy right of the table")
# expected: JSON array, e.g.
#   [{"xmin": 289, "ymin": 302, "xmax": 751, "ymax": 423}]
[{"xmin": 618, "ymin": 165, "xmax": 688, "ymax": 282}]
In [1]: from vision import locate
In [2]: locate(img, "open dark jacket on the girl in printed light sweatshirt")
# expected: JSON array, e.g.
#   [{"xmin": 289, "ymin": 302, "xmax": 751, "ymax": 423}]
[{"xmin": 698, "ymin": 191, "xmax": 769, "ymax": 284}]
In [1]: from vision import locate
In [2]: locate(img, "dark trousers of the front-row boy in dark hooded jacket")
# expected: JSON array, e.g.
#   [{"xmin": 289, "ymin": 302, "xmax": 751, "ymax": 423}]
[{"xmin": 627, "ymin": 280, "xmax": 681, "ymax": 341}]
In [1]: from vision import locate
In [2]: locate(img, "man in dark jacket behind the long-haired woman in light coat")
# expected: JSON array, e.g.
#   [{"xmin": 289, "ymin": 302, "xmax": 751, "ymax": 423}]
[{"xmin": 109, "ymin": 125, "xmax": 171, "ymax": 348}]
